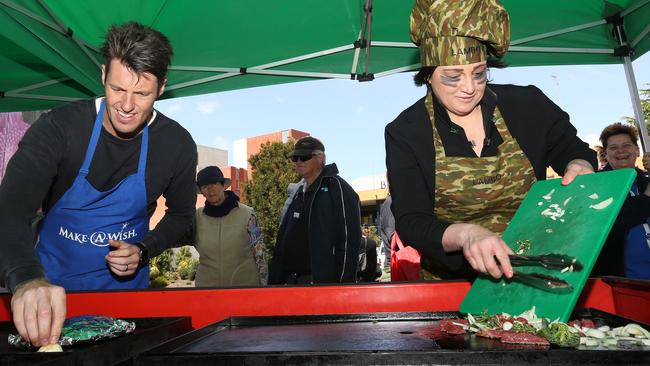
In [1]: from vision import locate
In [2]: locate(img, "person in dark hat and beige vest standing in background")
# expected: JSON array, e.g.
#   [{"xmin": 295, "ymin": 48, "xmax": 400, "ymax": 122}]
[{"xmin": 185, "ymin": 166, "xmax": 267, "ymax": 287}]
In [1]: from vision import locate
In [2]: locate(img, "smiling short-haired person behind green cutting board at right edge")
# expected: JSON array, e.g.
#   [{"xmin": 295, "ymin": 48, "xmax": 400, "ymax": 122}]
[{"xmin": 592, "ymin": 123, "xmax": 650, "ymax": 279}]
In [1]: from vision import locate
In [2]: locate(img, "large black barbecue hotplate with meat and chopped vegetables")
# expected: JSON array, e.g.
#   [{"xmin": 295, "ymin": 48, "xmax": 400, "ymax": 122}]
[{"xmin": 136, "ymin": 309, "xmax": 650, "ymax": 365}]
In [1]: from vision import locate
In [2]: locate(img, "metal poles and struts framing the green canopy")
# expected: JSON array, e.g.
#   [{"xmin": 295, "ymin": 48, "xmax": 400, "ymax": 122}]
[{"xmin": 0, "ymin": 0, "xmax": 650, "ymax": 151}]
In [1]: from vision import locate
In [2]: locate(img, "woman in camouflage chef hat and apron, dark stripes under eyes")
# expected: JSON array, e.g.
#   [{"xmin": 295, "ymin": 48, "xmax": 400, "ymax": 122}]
[{"xmin": 385, "ymin": 0, "xmax": 596, "ymax": 278}]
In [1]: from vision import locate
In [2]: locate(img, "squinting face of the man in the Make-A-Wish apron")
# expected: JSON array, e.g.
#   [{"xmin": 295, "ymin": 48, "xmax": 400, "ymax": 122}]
[{"xmin": 102, "ymin": 59, "xmax": 165, "ymax": 138}]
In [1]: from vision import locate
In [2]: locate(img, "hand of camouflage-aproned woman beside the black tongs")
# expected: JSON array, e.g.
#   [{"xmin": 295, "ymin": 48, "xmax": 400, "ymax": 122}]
[{"xmin": 442, "ymin": 224, "xmax": 513, "ymax": 278}]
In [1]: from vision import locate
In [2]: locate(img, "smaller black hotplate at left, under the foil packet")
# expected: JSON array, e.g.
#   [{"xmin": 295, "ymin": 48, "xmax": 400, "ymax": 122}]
[{"xmin": 0, "ymin": 317, "xmax": 192, "ymax": 366}]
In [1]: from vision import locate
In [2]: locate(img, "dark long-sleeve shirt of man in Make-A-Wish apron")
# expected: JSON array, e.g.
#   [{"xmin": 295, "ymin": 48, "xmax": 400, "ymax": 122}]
[{"xmin": 0, "ymin": 100, "xmax": 197, "ymax": 292}]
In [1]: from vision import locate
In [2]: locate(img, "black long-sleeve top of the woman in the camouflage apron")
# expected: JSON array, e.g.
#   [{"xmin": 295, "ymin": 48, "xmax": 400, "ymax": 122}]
[{"xmin": 385, "ymin": 84, "xmax": 596, "ymax": 271}]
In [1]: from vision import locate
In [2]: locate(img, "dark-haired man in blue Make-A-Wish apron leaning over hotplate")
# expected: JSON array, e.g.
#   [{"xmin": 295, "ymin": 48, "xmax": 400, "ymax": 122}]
[{"xmin": 0, "ymin": 23, "xmax": 197, "ymax": 346}]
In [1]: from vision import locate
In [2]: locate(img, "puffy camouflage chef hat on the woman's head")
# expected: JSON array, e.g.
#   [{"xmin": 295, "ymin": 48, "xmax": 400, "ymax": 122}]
[{"xmin": 411, "ymin": 0, "xmax": 510, "ymax": 66}]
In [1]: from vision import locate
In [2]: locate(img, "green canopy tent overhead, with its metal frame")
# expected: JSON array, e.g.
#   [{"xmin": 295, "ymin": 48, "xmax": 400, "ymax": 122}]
[{"xmin": 0, "ymin": 0, "xmax": 650, "ymax": 150}]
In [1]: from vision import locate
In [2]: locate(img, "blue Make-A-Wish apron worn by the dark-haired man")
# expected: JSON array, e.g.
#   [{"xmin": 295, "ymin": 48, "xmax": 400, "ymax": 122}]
[{"xmin": 36, "ymin": 100, "xmax": 149, "ymax": 290}]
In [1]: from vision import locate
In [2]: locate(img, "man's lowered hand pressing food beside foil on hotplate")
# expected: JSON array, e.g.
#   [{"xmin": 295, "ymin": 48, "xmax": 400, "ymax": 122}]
[{"xmin": 11, "ymin": 278, "xmax": 66, "ymax": 347}]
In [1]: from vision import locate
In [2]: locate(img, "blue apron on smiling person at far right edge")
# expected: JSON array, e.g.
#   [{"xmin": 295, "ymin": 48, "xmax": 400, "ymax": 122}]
[{"xmin": 625, "ymin": 183, "xmax": 650, "ymax": 280}]
